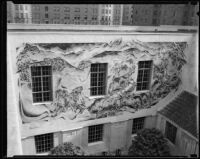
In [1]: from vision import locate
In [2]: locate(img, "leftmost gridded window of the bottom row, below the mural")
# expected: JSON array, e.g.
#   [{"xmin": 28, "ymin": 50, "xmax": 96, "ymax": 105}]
[{"xmin": 34, "ymin": 133, "xmax": 55, "ymax": 154}]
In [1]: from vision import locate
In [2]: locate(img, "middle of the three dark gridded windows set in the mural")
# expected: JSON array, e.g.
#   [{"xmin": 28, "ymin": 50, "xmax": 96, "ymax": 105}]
[{"xmin": 90, "ymin": 63, "xmax": 107, "ymax": 96}]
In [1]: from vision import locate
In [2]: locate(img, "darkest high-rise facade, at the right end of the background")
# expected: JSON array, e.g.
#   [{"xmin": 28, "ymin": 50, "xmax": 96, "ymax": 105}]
[{"xmin": 123, "ymin": 3, "xmax": 199, "ymax": 26}]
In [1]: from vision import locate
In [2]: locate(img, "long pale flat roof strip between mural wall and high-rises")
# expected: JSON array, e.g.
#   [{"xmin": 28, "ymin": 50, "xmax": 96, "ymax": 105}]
[{"xmin": 7, "ymin": 23, "xmax": 198, "ymax": 32}]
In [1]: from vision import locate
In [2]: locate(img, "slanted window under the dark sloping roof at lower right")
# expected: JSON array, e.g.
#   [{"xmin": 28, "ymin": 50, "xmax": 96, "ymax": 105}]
[{"xmin": 164, "ymin": 120, "xmax": 178, "ymax": 145}]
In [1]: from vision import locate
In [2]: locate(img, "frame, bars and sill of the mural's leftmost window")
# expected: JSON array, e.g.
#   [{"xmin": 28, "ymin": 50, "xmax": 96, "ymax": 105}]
[{"xmin": 29, "ymin": 65, "xmax": 53, "ymax": 105}]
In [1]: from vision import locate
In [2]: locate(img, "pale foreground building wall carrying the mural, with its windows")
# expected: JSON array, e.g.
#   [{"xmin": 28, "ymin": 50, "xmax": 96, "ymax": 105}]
[{"xmin": 7, "ymin": 25, "xmax": 198, "ymax": 156}]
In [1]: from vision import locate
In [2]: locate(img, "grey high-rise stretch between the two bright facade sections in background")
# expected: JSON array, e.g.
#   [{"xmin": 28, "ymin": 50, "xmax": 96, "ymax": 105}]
[{"xmin": 32, "ymin": 5, "xmax": 98, "ymax": 24}]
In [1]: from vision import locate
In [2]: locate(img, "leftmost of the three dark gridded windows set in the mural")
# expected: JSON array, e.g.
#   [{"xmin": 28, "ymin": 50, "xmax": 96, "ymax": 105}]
[{"xmin": 31, "ymin": 66, "xmax": 52, "ymax": 103}]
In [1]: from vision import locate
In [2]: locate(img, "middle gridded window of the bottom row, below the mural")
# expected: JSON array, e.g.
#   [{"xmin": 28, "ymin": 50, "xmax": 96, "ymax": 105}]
[{"xmin": 88, "ymin": 124, "xmax": 103, "ymax": 143}]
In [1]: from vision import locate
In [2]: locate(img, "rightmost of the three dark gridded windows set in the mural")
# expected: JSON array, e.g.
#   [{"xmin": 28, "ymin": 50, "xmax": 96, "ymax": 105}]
[{"xmin": 137, "ymin": 61, "xmax": 152, "ymax": 91}]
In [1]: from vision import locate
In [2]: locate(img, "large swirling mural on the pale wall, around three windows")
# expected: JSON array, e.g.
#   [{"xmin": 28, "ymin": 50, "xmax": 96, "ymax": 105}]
[{"xmin": 16, "ymin": 39, "xmax": 187, "ymax": 123}]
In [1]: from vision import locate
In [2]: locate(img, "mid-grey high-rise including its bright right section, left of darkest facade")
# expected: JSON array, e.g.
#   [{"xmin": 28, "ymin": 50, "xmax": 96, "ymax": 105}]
[{"xmin": 32, "ymin": 5, "xmax": 122, "ymax": 25}]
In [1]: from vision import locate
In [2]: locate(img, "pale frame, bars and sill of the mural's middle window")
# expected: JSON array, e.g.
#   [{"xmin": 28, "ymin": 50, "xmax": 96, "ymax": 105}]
[{"xmin": 90, "ymin": 63, "xmax": 108, "ymax": 98}]
